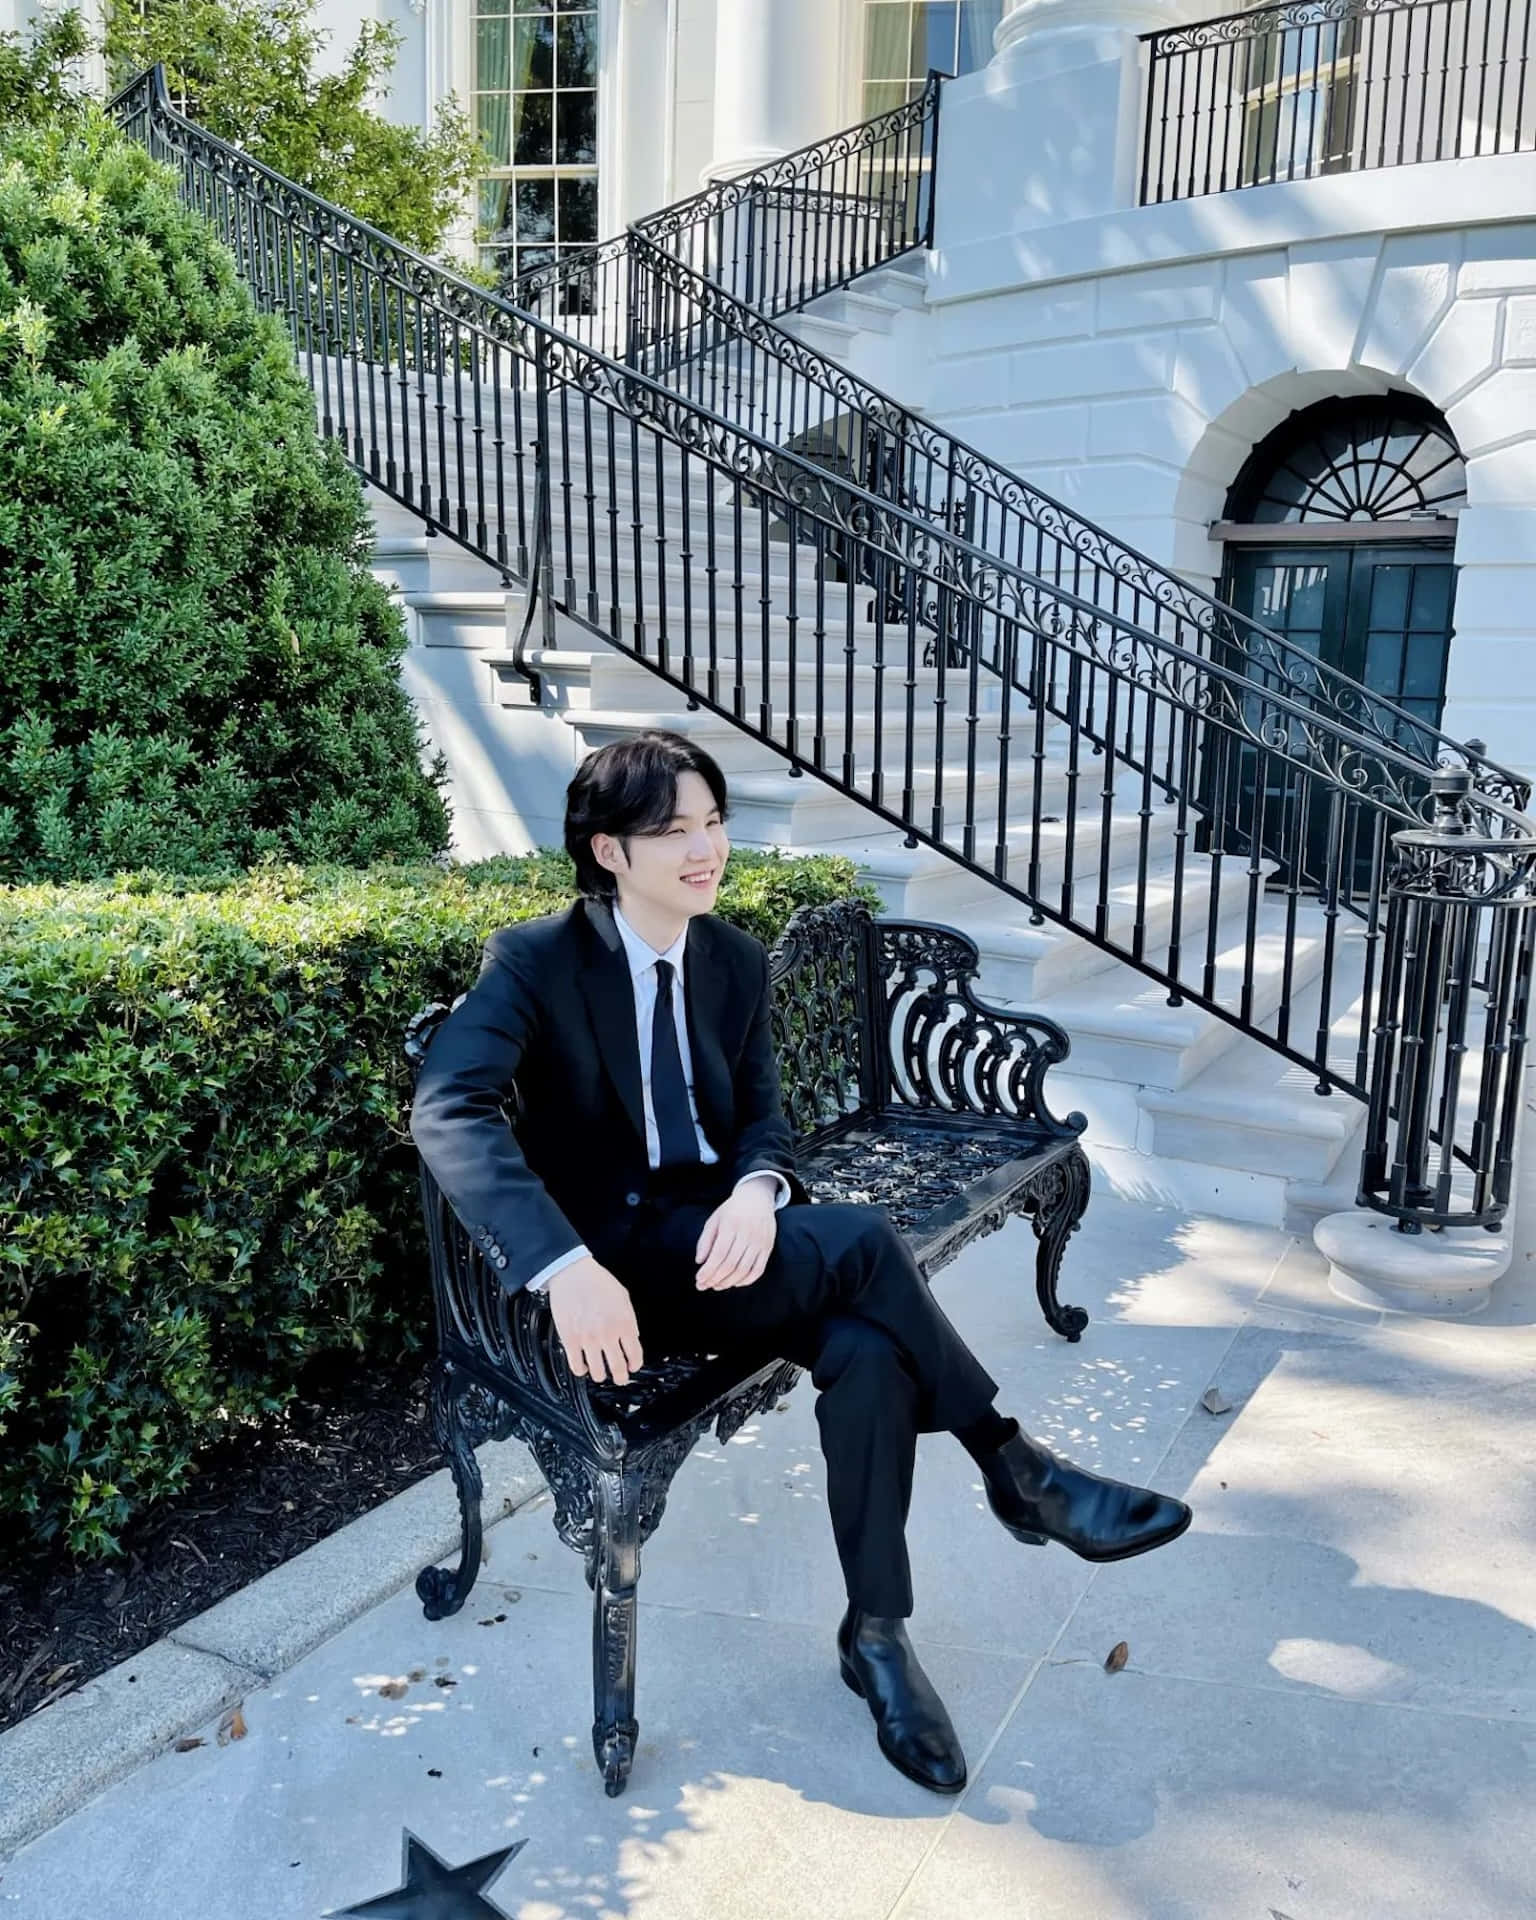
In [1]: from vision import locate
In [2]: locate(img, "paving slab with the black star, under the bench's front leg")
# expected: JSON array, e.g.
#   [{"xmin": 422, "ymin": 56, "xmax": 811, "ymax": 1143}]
[{"xmin": 0, "ymin": 1543, "xmax": 1033, "ymax": 1920}]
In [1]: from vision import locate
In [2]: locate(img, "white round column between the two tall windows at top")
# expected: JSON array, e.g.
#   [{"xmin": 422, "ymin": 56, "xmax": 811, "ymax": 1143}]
[{"xmin": 703, "ymin": 0, "xmax": 841, "ymax": 180}]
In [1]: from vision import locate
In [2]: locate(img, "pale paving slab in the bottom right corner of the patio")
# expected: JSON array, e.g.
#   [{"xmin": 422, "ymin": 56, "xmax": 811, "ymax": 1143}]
[{"xmin": 891, "ymin": 1666, "xmax": 1536, "ymax": 1920}]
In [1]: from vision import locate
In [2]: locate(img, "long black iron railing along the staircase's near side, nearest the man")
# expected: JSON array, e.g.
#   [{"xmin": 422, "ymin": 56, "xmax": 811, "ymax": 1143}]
[{"xmin": 115, "ymin": 73, "xmax": 1536, "ymax": 1236}]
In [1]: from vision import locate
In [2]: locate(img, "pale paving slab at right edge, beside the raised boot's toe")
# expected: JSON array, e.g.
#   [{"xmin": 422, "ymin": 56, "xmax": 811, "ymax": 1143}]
[{"xmin": 1056, "ymin": 1311, "xmax": 1536, "ymax": 1724}]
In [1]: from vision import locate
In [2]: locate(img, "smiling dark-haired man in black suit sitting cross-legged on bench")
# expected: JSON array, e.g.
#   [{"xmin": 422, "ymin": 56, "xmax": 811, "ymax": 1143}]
[{"xmin": 411, "ymin": 732, "xmax": 1190, "ymax": 1793}]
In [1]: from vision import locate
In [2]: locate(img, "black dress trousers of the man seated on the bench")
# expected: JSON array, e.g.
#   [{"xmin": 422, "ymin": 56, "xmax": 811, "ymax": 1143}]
[{"xmin": 593, "ymin": 1167, "xmax": 996, "ymax": 1619}]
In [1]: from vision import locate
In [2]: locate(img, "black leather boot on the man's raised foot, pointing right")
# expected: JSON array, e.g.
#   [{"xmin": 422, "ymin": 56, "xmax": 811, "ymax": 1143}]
[{"xmin": 977, "ymin": 1432, "xmax": 1192, "ymax": 1561}]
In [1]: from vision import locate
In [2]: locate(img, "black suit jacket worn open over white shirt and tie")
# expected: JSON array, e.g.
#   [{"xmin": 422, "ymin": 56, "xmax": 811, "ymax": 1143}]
[{"xmin": 411, "ymin": 900, "xmax": 810, "ymax": 1292}]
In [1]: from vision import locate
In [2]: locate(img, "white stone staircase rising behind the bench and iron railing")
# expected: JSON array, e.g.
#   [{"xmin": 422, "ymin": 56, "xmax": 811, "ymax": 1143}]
[{"xmin": 369, "ymin": 412, "xmax": 1363, "ymax": 1225}]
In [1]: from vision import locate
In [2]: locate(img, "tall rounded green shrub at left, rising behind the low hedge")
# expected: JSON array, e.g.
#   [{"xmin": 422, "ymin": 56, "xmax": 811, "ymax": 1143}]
[{"xmin": 0, "ymin": 108, "xmax": 449, "ymax": 881}]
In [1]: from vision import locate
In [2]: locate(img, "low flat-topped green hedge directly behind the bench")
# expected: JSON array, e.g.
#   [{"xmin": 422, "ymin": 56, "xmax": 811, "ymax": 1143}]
[{"xmin": 0, "ymin": 851, "xmax": 874, "ymax": 1557}]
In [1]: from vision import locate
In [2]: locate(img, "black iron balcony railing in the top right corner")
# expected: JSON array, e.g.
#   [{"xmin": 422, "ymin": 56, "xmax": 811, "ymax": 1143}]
[{"xmin": 1140, "ymin": 0, "xmax": 1536, "ymax": 204}]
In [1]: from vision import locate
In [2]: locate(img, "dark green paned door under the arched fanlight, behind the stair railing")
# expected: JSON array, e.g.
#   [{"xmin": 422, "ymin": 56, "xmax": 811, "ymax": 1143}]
[{"xmin": 1206, "ymin": 541, "xmax": 1455, "ymax": 885}]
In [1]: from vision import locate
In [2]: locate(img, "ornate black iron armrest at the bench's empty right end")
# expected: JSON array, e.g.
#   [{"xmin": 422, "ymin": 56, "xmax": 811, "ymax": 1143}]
[{"xmin": 876, "ymin": 920, "xmax": 1087, "ymax": 1140}]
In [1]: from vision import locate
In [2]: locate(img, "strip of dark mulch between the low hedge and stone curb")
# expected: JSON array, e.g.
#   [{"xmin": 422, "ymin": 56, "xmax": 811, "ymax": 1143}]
[{"xmin": 0, "ymin": 1361, "xmax": 445, "ymax": 1730}]
